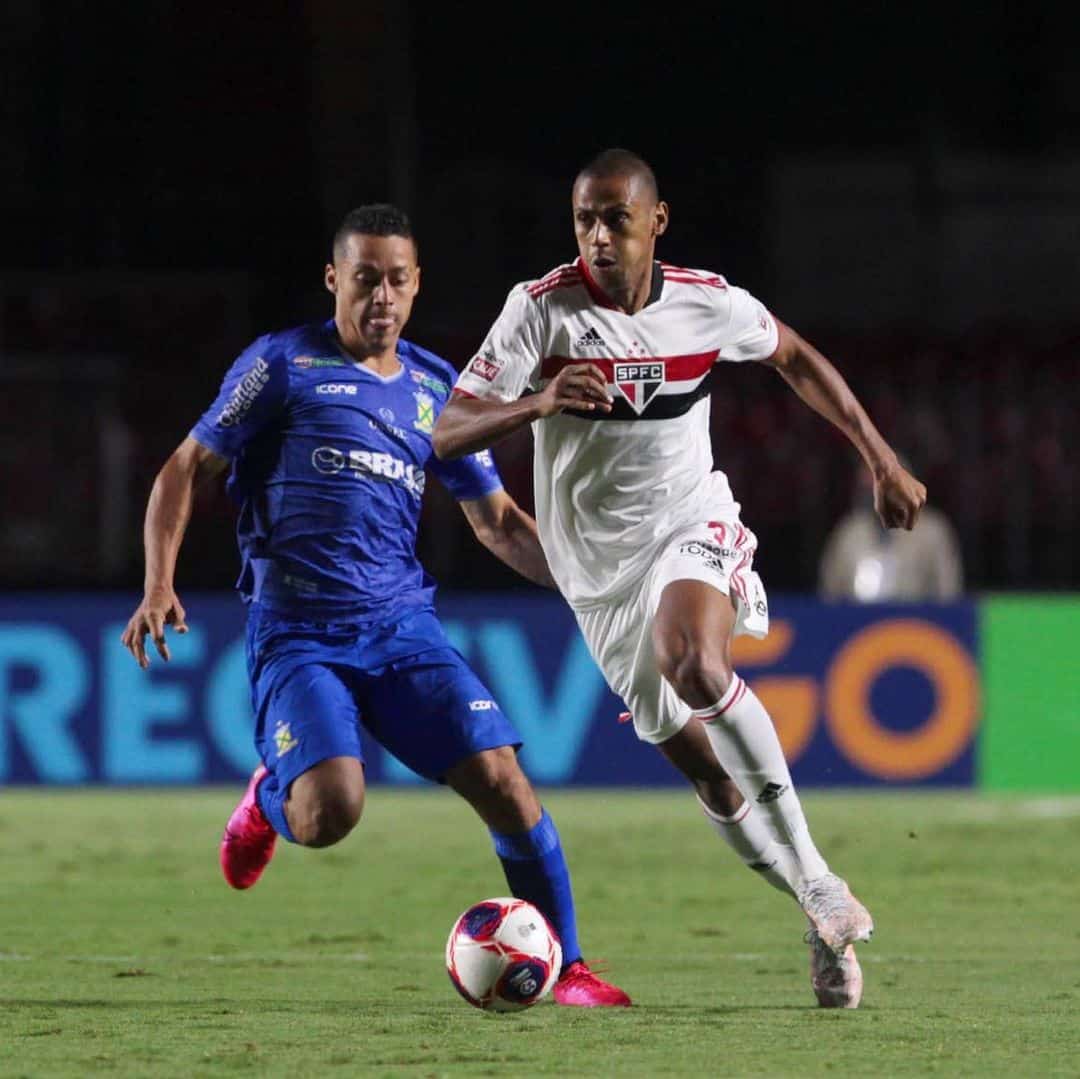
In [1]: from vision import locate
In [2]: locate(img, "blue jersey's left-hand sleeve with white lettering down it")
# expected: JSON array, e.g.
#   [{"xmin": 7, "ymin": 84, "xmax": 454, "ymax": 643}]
[{"xmin": 191, "ymin": 334, "xmax": 288, "ymax": 460}]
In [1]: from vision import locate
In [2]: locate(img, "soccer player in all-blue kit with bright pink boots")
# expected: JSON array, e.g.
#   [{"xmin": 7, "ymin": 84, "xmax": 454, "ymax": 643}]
[{"xmin": 122, "ymin": 204, "xmax": 630, "ymax": 1007}]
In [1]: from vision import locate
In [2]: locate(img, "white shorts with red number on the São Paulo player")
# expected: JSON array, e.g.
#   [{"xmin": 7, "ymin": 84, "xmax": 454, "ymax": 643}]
[{"xmin": 575, "ymin": 517, "xmax": 769, "ymax": 744}]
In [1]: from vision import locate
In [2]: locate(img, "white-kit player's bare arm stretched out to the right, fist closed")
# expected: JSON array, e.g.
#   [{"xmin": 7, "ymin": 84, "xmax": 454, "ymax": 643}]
[{"xmin": 766, "ymin": 319, "xmax": 927, "ymax": 529}]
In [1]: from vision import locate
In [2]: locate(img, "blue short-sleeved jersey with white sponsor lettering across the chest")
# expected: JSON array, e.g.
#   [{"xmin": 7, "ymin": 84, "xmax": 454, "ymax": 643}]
[{"xmin": 191, "ymin": 320, "xmax": 501, "ymax": 621}]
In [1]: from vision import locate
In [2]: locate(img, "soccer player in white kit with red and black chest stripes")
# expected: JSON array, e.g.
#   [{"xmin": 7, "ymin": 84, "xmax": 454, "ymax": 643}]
[{"xmin": 434, "ymin": 149, "xmax": 926, "ymax": 1008}]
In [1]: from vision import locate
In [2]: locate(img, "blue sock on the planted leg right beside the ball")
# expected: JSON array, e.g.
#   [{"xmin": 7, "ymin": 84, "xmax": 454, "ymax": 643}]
[{"xmin": 491, "ymin": 810, "xmax": 581, "ymax": 968}]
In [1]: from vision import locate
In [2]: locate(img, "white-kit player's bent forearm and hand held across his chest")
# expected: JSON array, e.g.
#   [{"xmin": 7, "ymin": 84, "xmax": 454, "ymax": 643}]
[{"xmin": 432, "ymin": 363, "xmax": 611, "ymax": 461}]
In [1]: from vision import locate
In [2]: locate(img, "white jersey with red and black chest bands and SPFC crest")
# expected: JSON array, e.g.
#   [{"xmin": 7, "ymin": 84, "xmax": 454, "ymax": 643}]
[{"xmin": 457, "ymin": 258, "xmax": 779, "ymax": 608}]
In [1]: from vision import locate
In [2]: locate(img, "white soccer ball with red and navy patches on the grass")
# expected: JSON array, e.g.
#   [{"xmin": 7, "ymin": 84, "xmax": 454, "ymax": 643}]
[{"xmin": 446, "ymin": 899, "xmax": 563, "ymax": 1012}]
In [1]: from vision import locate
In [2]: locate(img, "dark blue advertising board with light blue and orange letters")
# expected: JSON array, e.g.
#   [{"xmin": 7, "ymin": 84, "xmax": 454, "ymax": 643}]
[{"xmin": 0, "ymin": 591, "xmax": 980, "ymax": 786}]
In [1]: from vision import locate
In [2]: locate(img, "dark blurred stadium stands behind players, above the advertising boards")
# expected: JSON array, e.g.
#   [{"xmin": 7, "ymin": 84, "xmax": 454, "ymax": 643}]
[{"xmin": 0, "ymin": 0, "xmax": 1080, "ymax": 595}]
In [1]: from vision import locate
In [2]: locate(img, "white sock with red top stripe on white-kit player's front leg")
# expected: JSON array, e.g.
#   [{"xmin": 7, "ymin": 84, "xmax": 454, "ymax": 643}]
[{"xmin": 691, "ymin": 675, "xmax": 828, "ymax": 891}]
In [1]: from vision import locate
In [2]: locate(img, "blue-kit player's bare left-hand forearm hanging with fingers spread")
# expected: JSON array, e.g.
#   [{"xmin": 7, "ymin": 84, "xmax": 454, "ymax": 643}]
[{"xmin": 120, "ymin": 435, "xmax": 228, "ymax": 669}]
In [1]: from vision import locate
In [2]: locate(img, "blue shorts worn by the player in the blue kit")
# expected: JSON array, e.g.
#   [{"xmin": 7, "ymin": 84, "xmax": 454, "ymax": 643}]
[{"xmin": 247, "ymin": 605, "xmax": 522, "ymax": 786}]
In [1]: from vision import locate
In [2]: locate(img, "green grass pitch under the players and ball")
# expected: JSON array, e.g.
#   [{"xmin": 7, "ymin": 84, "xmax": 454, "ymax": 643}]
[{"xmin": 0, "ymin": 787, "xmax": 1080, "ymax": 1079}]
